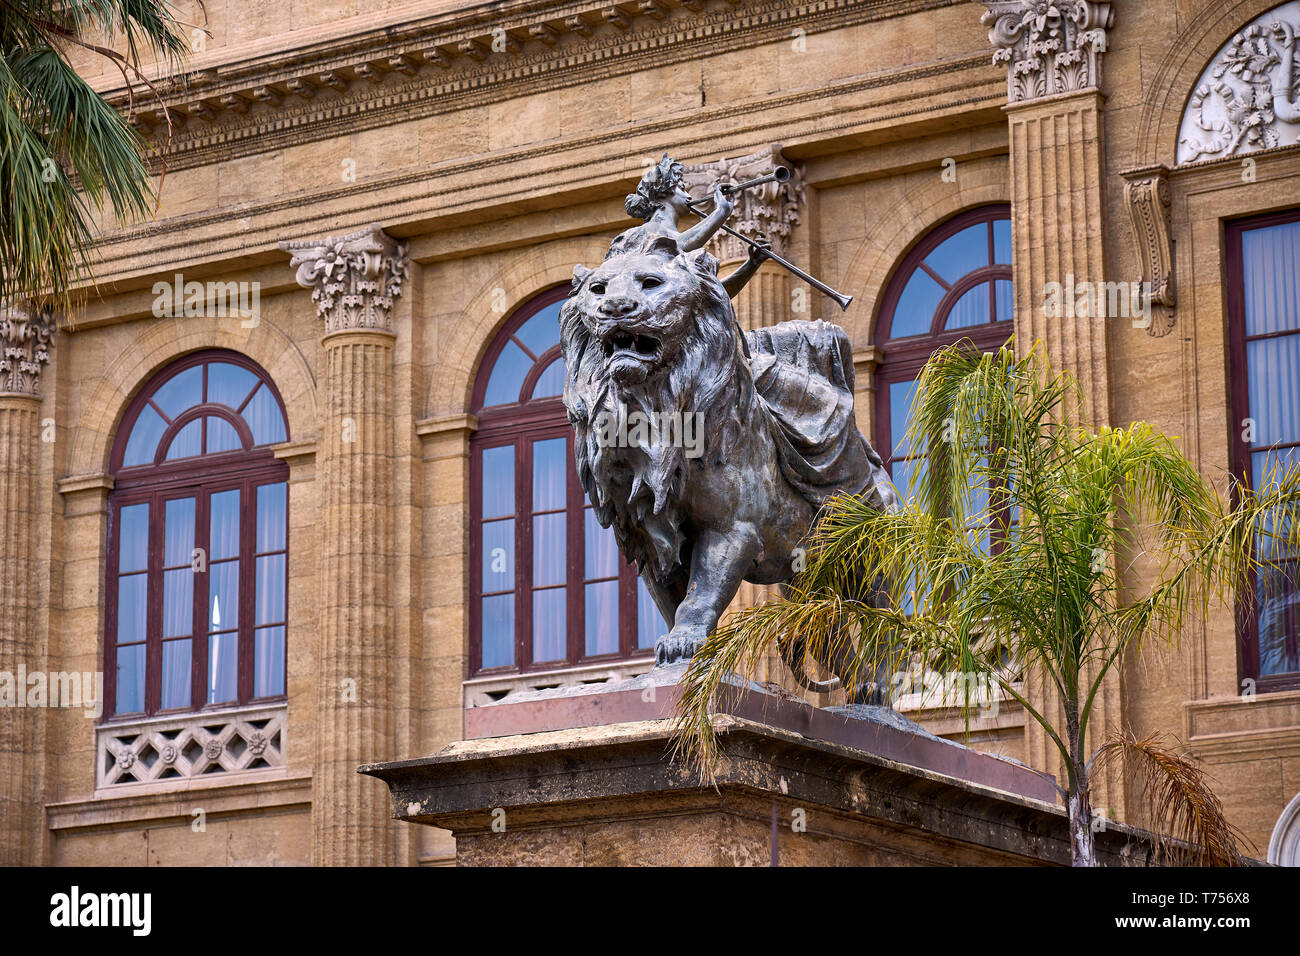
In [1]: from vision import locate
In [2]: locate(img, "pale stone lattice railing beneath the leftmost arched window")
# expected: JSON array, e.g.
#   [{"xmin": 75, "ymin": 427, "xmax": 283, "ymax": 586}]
[{"xmin": 95, "ymin": 704, "xmax": 286, "ymax": 788}]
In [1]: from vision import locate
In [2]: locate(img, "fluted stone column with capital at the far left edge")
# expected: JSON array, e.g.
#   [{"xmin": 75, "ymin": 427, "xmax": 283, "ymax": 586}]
[{"xmin": 0, "ymin": 307, "xmax": 53, "ymax": 865}]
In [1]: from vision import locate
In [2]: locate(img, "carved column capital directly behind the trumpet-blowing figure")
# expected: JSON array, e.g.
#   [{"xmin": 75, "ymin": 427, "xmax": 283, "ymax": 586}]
[{"xmin": 681, "ymin": 146, "xmax": 806, "ymax": 263}]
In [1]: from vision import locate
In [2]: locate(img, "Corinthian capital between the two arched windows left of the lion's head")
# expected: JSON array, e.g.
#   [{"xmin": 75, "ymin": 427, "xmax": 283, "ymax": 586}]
[{"xmin": 280, "ymin": 224, "xmax": 411, "ymax": 334}]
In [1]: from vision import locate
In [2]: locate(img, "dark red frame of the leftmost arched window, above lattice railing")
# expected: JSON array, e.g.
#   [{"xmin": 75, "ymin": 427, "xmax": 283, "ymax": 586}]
[{"xmin": 103, "ymin": 349, "xmax": 290, "ymax": 722}]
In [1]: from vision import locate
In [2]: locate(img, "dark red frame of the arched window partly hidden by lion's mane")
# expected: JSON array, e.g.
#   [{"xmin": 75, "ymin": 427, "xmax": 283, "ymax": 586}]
[{"xmin": 469, "ymin": 286, "xmax": 654, "ymax": 676}]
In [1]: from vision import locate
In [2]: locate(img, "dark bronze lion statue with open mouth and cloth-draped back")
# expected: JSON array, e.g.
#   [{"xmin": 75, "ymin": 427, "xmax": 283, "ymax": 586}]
[{"xmin": 560, "ymin": 227, "xmax": 897, "ymax": 672}]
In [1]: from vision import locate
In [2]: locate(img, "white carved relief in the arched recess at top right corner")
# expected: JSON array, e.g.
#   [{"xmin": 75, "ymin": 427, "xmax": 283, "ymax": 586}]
[{"xmin": 1178, "ymin": 0, "xmax": 1300, "ymax": 165}]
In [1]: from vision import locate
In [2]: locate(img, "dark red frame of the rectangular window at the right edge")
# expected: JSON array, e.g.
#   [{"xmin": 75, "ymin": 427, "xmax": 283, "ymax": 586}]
[{"xmin": 1225, "ymin": 208, "xmax": 1300, "ymax": 692}]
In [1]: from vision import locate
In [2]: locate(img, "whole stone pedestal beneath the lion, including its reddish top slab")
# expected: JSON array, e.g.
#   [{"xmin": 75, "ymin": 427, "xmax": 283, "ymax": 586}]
[{"xmin": 360, "ymin": 667, "xmax": 1170, "ymax": 866}]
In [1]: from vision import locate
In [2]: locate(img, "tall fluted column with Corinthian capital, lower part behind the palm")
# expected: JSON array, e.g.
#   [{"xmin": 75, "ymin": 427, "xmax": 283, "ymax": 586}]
[{"xmin": 983, "ymin": 0, "xmax": 1131, "ymax": 816}]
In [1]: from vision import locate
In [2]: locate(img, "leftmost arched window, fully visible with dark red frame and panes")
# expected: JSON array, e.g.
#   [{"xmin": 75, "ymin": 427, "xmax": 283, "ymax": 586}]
[{"xmin": 104, "ymin": 351, "xmax": 289, "ymax": 717}]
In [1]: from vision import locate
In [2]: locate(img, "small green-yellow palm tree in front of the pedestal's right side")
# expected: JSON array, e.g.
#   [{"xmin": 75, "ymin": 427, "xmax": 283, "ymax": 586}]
[{"xmin": 675, "ymin": 343, "xmax": 1300, "ymax": 865}]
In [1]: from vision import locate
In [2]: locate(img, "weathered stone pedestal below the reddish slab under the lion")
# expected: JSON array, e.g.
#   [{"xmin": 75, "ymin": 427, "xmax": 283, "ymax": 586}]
[{"xmin": 361, "ymin": 714, "xmax": 1152, "ymax": 866}]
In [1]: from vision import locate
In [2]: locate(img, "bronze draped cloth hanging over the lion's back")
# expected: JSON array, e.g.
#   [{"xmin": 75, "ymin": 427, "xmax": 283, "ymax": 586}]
[{"xmin": 745, "ymin": 320, "xmax": 885, "ymax": 507}]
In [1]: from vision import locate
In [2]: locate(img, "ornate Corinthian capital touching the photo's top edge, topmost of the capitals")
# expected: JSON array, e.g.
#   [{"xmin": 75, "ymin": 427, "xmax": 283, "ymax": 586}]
[{"xmin": 980, "ymin": 0, "xmax": 1115, "ymax": 103}]
